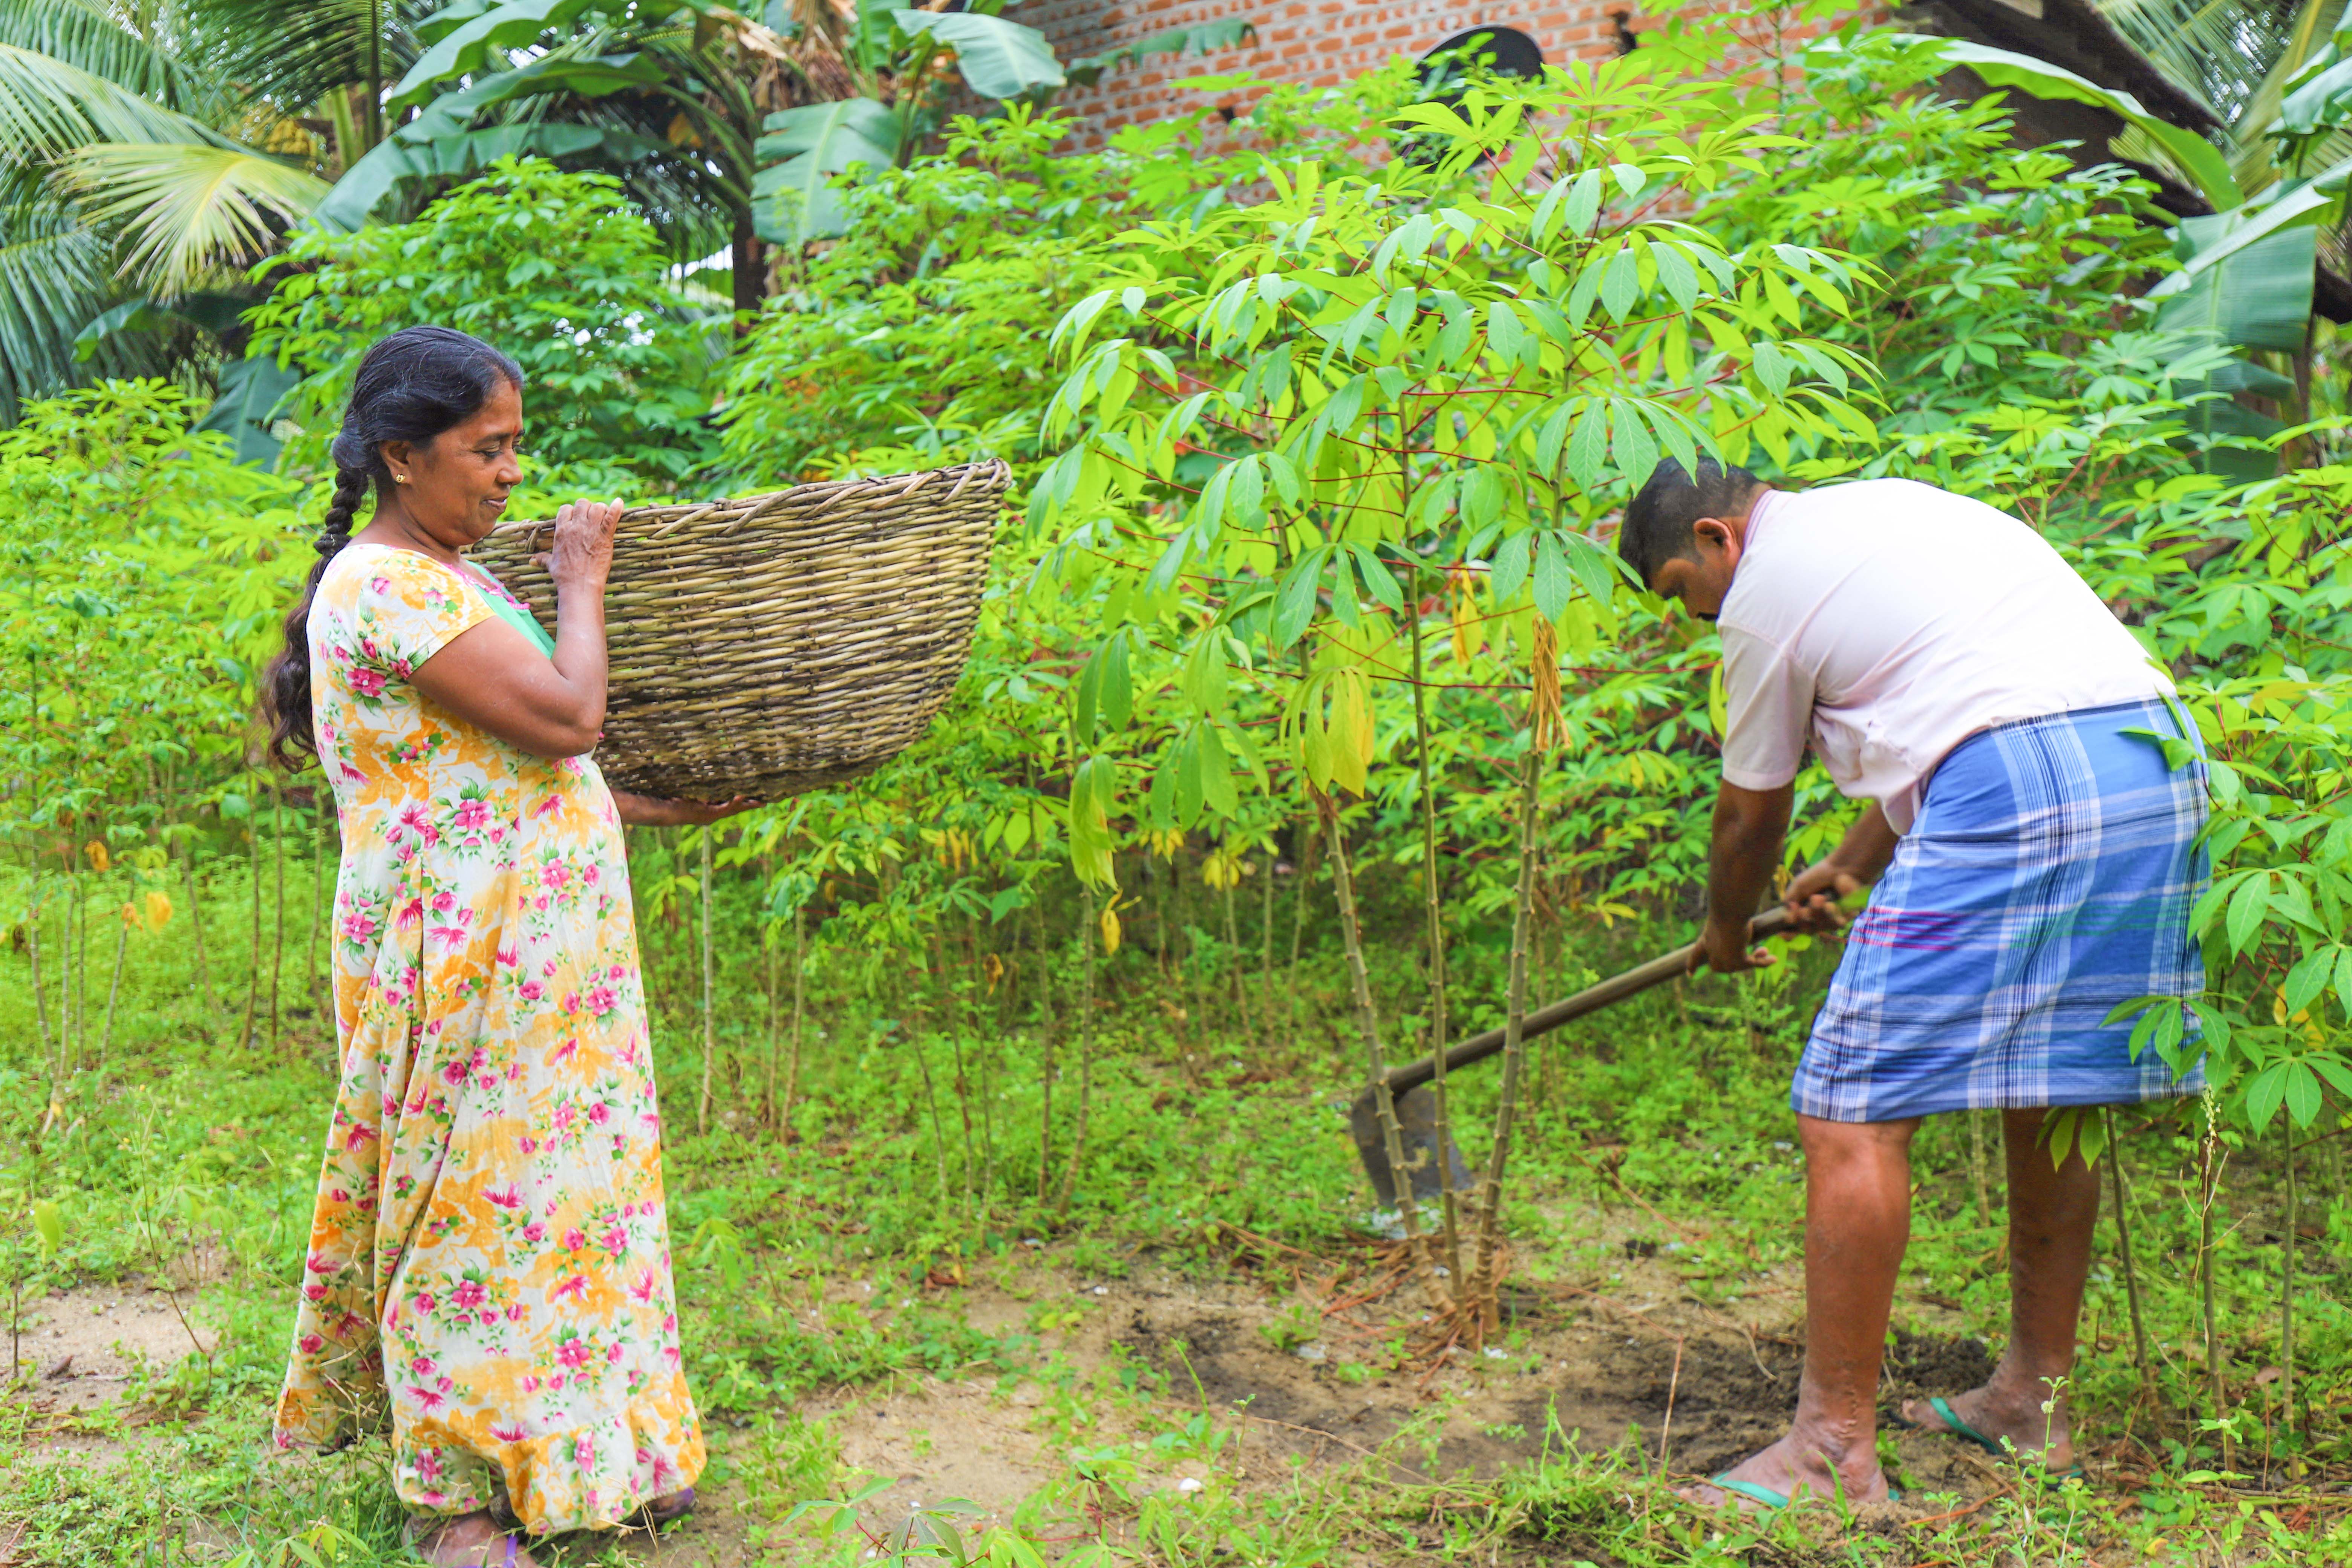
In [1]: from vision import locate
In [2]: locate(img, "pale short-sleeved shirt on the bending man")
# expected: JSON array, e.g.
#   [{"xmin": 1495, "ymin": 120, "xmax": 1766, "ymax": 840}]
[{"xmin": 1717, "ymin": 479, "xmax": 2173, "ymax": 832}]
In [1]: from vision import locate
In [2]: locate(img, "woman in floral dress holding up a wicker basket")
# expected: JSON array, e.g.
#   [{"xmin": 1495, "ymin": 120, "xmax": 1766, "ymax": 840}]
[{"xmin": 266, "ymin": 327, "xmax": 743, "ymax": 1568}]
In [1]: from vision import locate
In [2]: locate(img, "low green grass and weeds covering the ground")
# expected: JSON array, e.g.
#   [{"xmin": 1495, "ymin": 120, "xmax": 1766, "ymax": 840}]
[{"xmin": 0, "ymin": 851, "xmax": 2352, "ymax": 1568}]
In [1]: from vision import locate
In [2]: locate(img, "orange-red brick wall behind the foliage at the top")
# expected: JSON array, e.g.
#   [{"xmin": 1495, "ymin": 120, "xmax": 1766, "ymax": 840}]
[{"xmin": 1011, "ymin": 0, "xmax": 1884, "ymax": 150}]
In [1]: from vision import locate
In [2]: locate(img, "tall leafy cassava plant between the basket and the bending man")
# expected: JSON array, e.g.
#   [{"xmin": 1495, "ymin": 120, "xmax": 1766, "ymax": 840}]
[{"xmin": 1030, "ymin": 61, "xmax": 1870, "ymax": 1309}]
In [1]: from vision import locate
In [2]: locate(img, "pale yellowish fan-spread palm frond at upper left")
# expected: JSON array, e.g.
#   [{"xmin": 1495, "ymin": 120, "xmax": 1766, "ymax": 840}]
[{"xmin": 59, "ymin": 141, "xmax": 327, "ymax": 294}]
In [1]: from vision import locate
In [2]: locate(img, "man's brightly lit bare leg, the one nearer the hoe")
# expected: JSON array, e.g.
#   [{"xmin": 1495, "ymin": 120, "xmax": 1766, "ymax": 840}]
[{"xmin": 1691, "ymin": 1117, "xmax": 1919, "ymax": 1502}]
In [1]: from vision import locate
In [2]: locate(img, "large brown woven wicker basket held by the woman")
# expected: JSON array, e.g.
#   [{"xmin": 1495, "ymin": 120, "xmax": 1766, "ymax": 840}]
[{"xmin": 473, "ymin": 461, "xmax": 1011, "ymax": 802}]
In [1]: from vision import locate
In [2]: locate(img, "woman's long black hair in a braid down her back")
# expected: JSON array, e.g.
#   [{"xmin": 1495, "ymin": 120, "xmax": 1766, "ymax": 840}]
[{"xmin": 261, "ymin": 327, "xmax": 522, "ymax": 773}]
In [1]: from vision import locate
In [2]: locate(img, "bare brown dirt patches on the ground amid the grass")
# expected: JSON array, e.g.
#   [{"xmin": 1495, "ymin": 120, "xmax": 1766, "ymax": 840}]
[{"xmin": 18, "ymin": 1258, "xmax": 1999, "ymax": 1568}]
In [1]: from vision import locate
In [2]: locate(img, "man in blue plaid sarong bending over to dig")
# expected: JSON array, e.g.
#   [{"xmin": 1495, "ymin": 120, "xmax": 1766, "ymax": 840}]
[{"xmin": 1618, "ymin": 461, "xmax": 2204, "ymax": 1507}]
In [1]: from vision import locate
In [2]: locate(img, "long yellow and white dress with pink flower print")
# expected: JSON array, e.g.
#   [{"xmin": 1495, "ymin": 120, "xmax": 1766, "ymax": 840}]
[{"xmin": 277, "ymin": 543, "xmax": 703, "ymax": 1533}]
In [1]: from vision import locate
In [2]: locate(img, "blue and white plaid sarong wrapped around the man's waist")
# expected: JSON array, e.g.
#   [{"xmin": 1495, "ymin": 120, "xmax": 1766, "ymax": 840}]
[{"xmin": 1790, "ymin": 698, "xmax": 2206, "ymax": 1121}]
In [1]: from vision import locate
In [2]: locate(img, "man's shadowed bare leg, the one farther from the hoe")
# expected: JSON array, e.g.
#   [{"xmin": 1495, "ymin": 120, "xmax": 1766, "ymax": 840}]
[{"xmin": 1903, "ymin": 1110, "xmax": 2098, "ymax": 1469}]
